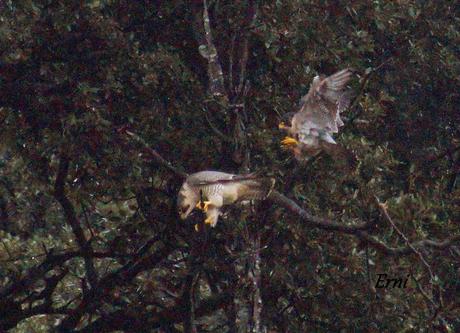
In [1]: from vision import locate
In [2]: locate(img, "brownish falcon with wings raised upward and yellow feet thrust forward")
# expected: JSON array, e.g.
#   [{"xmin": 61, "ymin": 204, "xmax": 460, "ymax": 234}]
[{"xmin": 279, "ymin": 69, "xmax": 353, "ymax": 160}]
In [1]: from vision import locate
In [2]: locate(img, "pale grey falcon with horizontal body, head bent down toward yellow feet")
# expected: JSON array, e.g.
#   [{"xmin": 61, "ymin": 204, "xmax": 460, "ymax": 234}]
[{"xmin": 177, "ymin": 171, "xmax": 275, "ymax": 227}]
